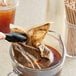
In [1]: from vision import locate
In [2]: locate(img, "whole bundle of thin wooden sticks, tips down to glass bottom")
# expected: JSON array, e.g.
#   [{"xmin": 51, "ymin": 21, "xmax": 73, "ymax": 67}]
[{"xmin": 65, "ymin": 0, "xmax": 76, "ymax": 56}]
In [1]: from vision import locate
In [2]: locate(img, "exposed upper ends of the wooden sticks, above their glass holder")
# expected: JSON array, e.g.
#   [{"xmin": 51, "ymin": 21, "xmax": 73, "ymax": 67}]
[{"xmin": 65, "ymin": 0, "xmax": 76, "ymax": 24}]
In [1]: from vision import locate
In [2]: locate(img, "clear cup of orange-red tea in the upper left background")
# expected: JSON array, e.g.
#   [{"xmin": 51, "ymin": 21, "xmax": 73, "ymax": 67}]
[{"xmin": 0, "ymin": 0, "xmax": 18, "ymax": 33}]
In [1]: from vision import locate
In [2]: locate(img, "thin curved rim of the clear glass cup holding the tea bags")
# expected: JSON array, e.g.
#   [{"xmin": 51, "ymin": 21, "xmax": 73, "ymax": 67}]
[{"xmin": 9, "ymin": 30, "xmax": 66, "ymax": 71}]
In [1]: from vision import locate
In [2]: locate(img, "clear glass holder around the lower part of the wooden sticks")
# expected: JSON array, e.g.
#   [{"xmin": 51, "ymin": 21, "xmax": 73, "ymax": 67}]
[{"xmin": 65, "ymin": 21, "xmax": 76, "ymax": 57}]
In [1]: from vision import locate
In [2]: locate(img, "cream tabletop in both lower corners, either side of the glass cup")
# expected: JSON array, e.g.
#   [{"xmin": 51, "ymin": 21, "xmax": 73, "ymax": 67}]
[{"xmin": 0, "ymin": 40, "xmax": 76, "ymax": 76}]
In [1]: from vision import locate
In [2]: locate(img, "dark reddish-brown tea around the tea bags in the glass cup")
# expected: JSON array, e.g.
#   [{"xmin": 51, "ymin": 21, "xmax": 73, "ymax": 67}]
[{"xmin": 14, "ymin": 45, "xmax": 61, "ymax": 68}]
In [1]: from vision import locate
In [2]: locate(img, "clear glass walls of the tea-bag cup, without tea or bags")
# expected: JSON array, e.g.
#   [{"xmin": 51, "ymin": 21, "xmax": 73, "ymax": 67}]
[{"xmin": 8, "ymin": 31, "xmax": 65, "ymax": 76}]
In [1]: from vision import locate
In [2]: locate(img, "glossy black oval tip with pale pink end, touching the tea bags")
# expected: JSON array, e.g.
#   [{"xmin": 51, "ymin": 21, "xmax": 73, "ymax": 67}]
[{"xmin": 0, "ymin": 32, "xmax": 27, "ymax": 42}]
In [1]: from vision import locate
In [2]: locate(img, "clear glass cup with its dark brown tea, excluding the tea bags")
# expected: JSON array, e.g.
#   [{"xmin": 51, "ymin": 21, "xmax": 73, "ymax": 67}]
[{"xmin": 9, "ymin": 31, "xmax": 65, "ymax": 76}]
